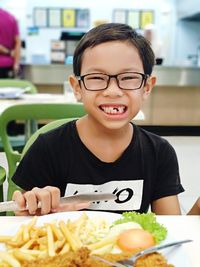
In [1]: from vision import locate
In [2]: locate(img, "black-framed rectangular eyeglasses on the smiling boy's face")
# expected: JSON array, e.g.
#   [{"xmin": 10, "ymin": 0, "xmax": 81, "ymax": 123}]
[{"xmin": 76, "ymin": 72, "xmax": 149, "ymax": 91}]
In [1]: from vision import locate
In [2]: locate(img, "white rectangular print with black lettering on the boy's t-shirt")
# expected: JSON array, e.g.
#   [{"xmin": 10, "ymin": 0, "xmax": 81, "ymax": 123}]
[{"xmin": 65, "ymin": 180, "xmax": 143, "ymax": 210}]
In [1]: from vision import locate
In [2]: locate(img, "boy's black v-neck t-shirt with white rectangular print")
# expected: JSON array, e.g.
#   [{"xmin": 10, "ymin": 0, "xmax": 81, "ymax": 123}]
[{"xmin": 12, "ymin": 121, "xmax": 184, "ymax": 212}]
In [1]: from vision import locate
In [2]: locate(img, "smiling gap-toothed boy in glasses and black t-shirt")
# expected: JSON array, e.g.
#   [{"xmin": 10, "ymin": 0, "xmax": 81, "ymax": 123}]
[{"xmin": 13, "ymin": 23, "xmax": 184, "ymax": 214}]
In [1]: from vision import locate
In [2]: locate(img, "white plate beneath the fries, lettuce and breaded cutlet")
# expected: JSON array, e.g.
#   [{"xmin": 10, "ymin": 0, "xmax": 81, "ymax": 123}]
[{"xmin": 0, "ymin": 211, "xmax": 192, "ymax": 267}]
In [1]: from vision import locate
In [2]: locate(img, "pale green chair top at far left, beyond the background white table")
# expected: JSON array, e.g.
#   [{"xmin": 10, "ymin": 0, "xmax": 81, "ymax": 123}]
[{"xmin": 0, "ymin": 79, "xmax": 38, "ymax": 94}]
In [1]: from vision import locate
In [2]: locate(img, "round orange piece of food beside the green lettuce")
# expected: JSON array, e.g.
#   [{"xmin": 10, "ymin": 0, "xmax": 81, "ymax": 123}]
[{"xmin": 117, "ymin": 229, "xmax": 155, "ymax": 252}]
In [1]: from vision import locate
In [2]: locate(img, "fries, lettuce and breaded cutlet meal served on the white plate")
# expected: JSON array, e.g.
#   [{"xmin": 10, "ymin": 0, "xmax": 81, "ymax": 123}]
[{"xmin": 0, "ymin": 212, "xmax": 173, "ymax": 267}]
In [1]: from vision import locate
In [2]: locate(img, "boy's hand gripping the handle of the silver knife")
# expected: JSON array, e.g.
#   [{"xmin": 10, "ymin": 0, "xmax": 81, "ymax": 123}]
[{"xmin": 13, "ymin": 186, "xmax": 90, "ymax": 216}]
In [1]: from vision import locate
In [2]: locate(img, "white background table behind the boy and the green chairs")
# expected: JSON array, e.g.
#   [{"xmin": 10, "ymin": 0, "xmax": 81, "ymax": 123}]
[{"xmin": 0, "ymin": 93, "xmax": 145, "ymax": 120}]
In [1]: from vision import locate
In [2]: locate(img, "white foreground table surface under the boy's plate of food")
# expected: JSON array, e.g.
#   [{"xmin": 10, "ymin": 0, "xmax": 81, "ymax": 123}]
[{"xmin": 0, "ymin": 215, "xmax": 200, "ymax": 267}]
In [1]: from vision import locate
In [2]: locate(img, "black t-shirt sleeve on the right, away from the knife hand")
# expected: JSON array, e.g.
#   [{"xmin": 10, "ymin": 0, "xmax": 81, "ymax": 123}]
[{"xmin": 152, "ymin": 141, "xmax": 184, "ymax": 200}]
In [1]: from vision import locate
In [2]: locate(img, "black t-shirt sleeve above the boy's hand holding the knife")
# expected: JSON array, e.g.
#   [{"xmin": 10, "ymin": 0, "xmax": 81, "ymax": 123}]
[{"xmin": 12, "ymin": 135, "xmax": 54, "ymax": 190}]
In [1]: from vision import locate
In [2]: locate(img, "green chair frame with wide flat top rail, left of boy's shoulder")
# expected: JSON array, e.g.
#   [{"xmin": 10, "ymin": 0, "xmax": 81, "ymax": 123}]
[{"xmin": 0, "ymin": 103, "xmax": 85, "ymax": 200}]
